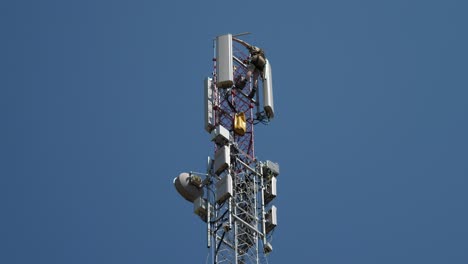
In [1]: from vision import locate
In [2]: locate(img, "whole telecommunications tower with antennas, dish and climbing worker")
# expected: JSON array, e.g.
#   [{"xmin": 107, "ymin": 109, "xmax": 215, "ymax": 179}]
[{"xmin": 174, "ymin": 33, "xmax": 279, "ymax": 264}]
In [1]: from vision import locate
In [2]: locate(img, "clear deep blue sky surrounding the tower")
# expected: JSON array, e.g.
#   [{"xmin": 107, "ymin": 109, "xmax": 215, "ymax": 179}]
[{"xmin": 0, "ymin": 0, "xmax": 468, "ymax": 264}]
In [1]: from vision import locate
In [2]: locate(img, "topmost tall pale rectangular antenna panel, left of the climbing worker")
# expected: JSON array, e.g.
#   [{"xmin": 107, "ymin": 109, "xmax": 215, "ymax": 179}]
[{"xmin": 216, "ymin": 34, "xmax": 234, "ymax": 88}]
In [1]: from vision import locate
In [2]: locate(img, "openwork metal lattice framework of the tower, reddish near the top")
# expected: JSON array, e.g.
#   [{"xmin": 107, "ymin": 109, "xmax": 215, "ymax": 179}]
[{"xmin": 208, "ymin": 35, "xmax": 274, "ymax": 264}]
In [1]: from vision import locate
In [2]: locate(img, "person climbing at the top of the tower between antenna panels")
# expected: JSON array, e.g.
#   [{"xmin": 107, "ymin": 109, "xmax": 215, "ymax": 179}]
[{"xmin": 232, "ymin": 38, "xmax": 266, "ymax": 98}]
